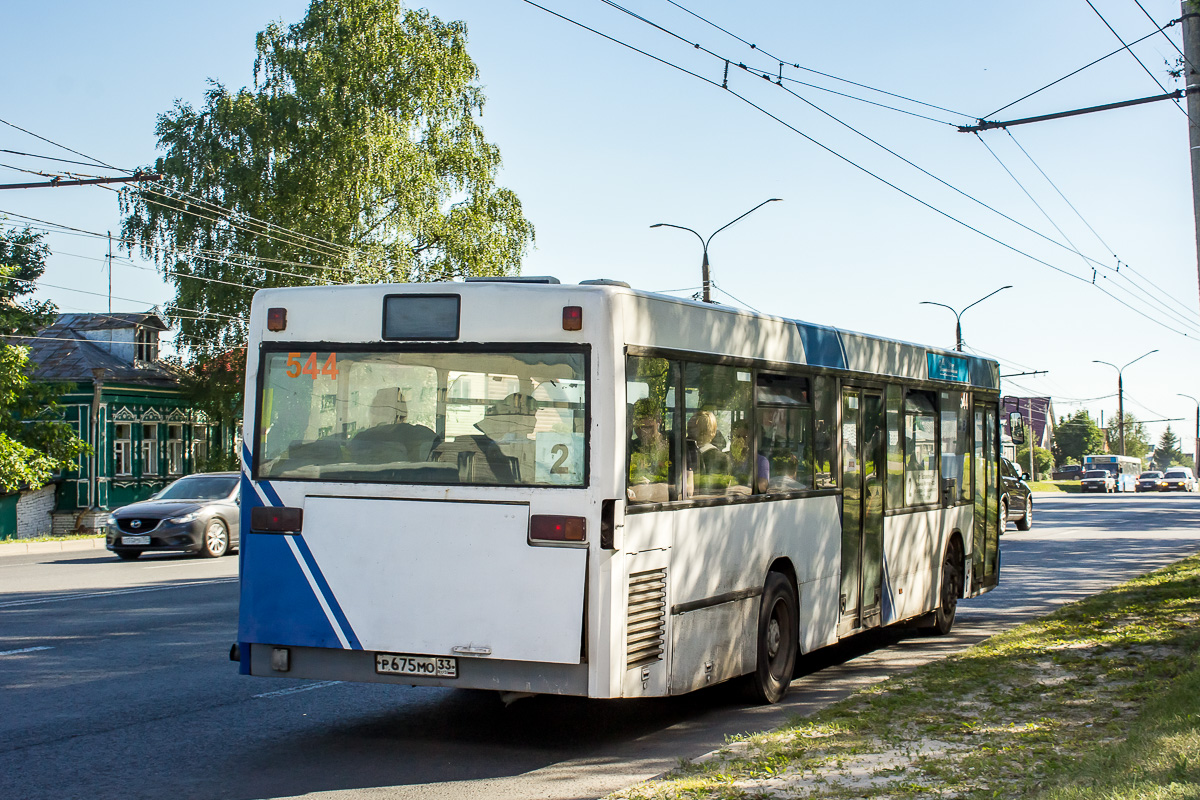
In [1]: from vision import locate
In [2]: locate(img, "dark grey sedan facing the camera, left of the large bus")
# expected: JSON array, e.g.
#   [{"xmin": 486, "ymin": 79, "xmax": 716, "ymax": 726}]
[{"xmin": 106, "ymin": 473, "xmax": 241, "ymax": 559}]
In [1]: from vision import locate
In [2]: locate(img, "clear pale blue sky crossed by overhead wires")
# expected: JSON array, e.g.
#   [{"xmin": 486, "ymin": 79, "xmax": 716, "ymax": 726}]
[{"xmin": 0, "ymin": 0, "xmax": 1200, "ymax": 451}]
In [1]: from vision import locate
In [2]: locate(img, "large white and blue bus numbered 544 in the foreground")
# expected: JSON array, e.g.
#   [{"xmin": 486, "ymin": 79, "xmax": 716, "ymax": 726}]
[{"xmin": 232, "ymin": 278, "xmax": 1001, "ymax": 702}]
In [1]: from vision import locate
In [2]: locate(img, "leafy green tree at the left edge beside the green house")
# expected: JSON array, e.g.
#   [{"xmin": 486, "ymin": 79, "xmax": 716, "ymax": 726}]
[{"xmin": 0, "ymin": 228, "xmax": 88, "ymax": 492}]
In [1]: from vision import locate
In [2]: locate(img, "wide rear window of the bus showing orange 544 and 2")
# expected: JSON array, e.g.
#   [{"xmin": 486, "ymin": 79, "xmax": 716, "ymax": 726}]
[{"xmin": 256, "ymin": 350, "xmax": 587, "ymax": 486}]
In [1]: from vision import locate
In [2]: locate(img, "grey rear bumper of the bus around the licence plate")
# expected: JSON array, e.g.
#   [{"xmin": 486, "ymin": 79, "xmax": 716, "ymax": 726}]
[{"xmin": 241, "ymin": 644, "xmax": 588, "ymax": 697}]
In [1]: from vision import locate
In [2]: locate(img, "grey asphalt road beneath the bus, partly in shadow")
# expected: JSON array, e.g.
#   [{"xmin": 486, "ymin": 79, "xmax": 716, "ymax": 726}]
[{"xmin": 0, "ymin": 494, "xmax": 1200, "ymax": 800}]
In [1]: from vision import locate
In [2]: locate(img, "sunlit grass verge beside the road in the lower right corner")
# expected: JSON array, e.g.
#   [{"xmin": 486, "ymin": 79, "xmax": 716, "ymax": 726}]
[{"xmin": 617, "ymin": 557, "xmax": 1200, "ymax": 800}]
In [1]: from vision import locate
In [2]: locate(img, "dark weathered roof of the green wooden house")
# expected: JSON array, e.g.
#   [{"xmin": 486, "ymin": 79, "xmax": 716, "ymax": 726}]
[{"xmin": 10, "ymin": 312, "xmax": 184, "ymax": 386}]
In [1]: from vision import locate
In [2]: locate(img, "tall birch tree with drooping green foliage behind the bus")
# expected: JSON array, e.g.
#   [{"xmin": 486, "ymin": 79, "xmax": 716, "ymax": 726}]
[{"xmin": 122, "ymin": 0, "xmax": 534, "ymax": 366}]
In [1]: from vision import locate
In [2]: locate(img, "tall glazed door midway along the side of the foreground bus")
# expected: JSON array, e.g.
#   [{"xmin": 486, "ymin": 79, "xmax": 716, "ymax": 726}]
[{"xmin": 838, "ymin": 386, "xmax": 886, "ymax": 636}]
